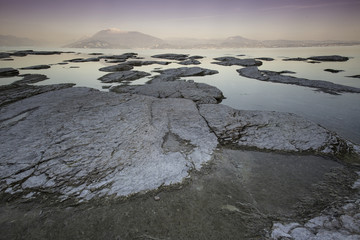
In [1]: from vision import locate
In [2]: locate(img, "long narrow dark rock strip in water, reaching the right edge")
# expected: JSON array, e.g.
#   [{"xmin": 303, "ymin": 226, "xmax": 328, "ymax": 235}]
[{"xmin": 236, "ymin": 67, "xmax": 360, "ymax": 94}]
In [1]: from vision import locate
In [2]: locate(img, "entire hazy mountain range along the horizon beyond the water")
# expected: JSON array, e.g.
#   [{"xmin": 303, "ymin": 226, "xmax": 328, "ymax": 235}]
[{"xmin": 0, "ymin": 28, "xmax": 360, "ymax": 49}]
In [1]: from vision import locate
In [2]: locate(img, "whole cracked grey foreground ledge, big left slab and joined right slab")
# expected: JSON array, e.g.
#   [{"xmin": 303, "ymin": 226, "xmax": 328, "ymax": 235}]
[{"xmin": 0, "ymin": 88, "xmax": 360, "ymax": 201}]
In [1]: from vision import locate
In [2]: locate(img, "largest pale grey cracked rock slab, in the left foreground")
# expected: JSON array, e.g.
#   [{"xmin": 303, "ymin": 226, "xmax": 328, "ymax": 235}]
[{"xmin": 0, "ymin": 88, "xmax": 217, "ymax": 200}]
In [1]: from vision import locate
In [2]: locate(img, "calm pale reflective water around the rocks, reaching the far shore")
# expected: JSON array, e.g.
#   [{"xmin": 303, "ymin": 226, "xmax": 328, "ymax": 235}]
[{"xmin": 0, "ymin": 46, "xmax": 360, "ymax": 143}]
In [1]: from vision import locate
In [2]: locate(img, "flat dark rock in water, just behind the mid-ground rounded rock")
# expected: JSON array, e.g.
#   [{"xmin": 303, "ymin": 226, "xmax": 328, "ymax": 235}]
[{"xmin": 151, "ymin": 67, "xmax": 219, "ymax": 83}]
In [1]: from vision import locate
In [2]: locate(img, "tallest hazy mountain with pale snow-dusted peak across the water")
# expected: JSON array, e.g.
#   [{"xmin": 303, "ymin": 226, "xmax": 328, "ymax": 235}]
[{"xmin": 66, "ymin": 28, "xmax": 165, "ymax": 49}]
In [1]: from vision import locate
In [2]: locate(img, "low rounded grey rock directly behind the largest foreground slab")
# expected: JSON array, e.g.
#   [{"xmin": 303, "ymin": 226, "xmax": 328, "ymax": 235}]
[{"xmin": 110, "ymin": 80, "xmax": 224, "ymax": 104}]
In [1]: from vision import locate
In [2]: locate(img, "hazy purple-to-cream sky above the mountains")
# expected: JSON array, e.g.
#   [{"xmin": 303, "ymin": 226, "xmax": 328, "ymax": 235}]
[{"xmin": 0, "ymin": 0, "xmax": 360, "ymax": 44}]
